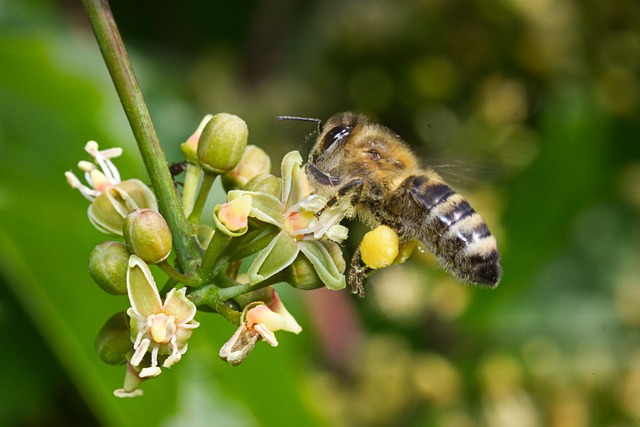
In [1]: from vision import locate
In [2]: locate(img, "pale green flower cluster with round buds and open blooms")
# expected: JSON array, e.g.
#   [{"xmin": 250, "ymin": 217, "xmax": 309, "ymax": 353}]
[{"xmin": 65, "ymin": 114, "xmax": 347, "ymax": 397}]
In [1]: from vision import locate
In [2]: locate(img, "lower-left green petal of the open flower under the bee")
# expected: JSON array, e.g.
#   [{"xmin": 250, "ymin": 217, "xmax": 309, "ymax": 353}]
[{"xmin": 247, "ymin": 231, "xmax": 299, "ymax": 284}]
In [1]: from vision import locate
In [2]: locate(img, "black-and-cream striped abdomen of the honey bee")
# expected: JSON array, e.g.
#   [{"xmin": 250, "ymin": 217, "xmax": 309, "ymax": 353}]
[{"xmin": 399, "ymin": 175, "xmax": 502, "ymax": 286}]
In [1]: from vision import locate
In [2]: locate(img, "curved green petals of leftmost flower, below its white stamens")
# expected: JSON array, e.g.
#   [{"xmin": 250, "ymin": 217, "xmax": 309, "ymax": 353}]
[{"xmin": 89, "ymin": 179, "xmax": 158, "ymax": 236}]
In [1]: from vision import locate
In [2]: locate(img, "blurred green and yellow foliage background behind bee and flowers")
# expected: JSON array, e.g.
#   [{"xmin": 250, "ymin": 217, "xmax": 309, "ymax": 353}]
[{"xmin": 0, "ymin": 0, "xmax": 640, "ymax": 427}]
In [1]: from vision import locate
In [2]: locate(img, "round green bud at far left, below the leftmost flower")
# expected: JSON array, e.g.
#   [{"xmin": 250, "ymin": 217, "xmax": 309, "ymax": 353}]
[{"xmin": 89, "ymin": 242, "xmax": 130, "ymax": 295}]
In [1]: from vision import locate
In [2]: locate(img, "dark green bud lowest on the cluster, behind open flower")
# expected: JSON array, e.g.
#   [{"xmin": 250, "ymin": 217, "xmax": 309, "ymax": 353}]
[{"xmin": 95, "ymin": 311, "xmax": 133, "ymax": 365}]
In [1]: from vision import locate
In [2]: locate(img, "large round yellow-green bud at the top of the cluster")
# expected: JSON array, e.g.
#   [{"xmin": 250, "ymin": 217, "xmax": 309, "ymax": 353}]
[{"xmin": 198, "ymin": 113, "xmax": 249, "ymax": 174}]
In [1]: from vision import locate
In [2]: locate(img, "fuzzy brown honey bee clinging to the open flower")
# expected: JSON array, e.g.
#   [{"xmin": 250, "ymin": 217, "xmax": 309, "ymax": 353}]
[{"xmin": 282, "ymin": 112, "xmax": 502, "ymax": 296}]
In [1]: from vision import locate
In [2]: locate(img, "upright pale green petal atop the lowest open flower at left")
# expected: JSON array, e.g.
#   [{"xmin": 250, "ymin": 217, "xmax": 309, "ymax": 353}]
[{"xmin": 127, "ymin": 255, "xmax": 162, "ymax": 317}]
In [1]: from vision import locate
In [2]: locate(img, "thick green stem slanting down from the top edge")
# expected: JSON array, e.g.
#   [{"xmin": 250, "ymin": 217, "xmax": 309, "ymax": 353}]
[{"xmin": 83, "ymin": 0, "xmax": 200, "ymax": 274}]
